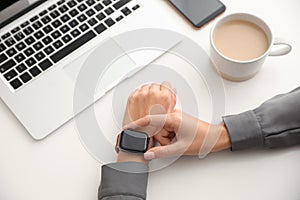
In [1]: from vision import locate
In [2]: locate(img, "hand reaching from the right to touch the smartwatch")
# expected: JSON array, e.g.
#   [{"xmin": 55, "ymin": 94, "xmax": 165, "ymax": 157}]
[{"xmin": 125, "ymin": 110, "xmax": 231, "ymax": 160}]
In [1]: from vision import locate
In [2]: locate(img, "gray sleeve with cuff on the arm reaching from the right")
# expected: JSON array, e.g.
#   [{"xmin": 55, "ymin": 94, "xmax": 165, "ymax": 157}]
[{"xmin": 223, "ymin": 87, "xmax": 300, "ymax": 151}]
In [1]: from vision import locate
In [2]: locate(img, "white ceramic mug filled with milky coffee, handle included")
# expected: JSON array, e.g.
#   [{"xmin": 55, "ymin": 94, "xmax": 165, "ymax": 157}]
[{"xmin": 210, "ymin": 13, "xmax": 292, "ymax": 81}]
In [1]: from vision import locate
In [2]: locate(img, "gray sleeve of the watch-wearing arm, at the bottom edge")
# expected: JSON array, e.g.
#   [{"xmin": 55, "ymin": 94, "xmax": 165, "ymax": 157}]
[{"xmin": 98, "ymin": 162, "xmax": 148, "ymax": 200}]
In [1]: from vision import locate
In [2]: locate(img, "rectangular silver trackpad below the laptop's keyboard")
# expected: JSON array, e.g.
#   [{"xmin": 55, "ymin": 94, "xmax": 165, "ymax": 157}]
[{"xmin": 64, "ymin": 39, "xmax": 136, "ymax": 98}]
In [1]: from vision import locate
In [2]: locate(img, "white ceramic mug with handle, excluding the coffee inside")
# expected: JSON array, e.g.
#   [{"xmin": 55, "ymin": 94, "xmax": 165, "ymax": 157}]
[{"xmin": 210, "ymin": 13, "xmax": 292, "ymax": 81}]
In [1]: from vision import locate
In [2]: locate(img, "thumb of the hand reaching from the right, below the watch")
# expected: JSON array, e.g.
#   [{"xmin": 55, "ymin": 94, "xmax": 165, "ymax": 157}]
[{"xmin": 144, "ymin": 143, "xmax": 180, "ymax": 160}]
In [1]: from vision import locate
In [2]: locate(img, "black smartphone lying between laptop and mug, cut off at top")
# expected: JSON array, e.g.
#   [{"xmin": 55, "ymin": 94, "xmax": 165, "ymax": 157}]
[{"xmin": 169, "ymin": 0, "xmax": 226, "ymax": 28}]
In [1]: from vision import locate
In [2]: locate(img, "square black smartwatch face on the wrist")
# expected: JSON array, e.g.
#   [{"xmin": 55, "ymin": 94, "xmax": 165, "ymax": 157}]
[{"xmin": 120, "ymin": 130, "xmax": 149, "ymax": 153}]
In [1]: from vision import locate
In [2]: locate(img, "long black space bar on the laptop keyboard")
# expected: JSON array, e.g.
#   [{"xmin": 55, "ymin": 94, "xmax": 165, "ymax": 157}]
[{"xmin": 50, "ymin": 30, "xmax": 96, "ymax": 63}]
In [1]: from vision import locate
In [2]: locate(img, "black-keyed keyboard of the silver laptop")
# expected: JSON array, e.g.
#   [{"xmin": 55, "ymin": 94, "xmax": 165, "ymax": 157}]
[{"xmin": 0, "ymin": 0, "xmax": 140, "ymax": 90}]
